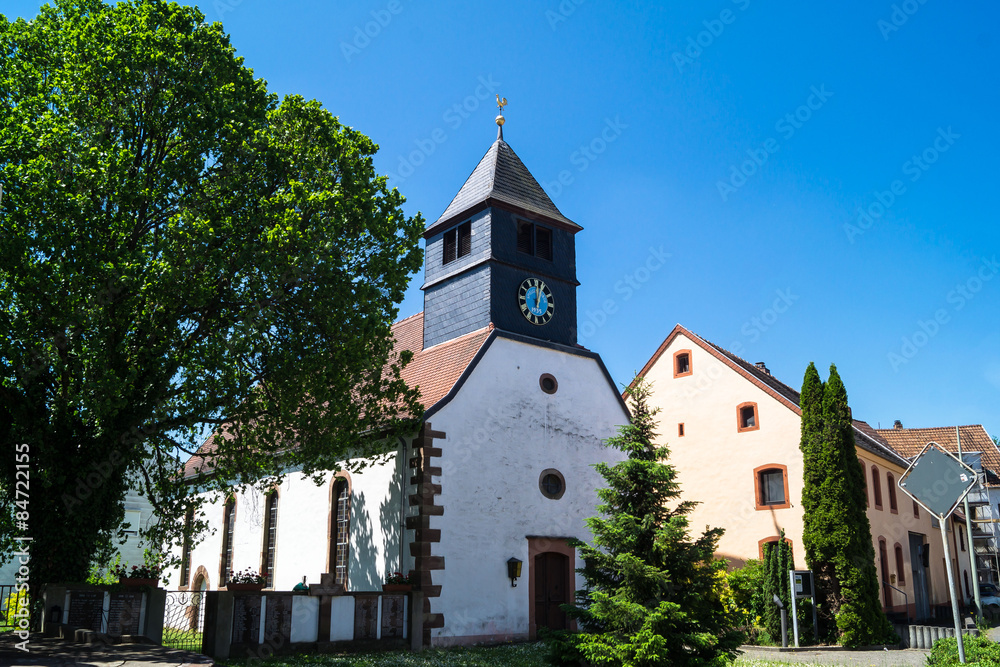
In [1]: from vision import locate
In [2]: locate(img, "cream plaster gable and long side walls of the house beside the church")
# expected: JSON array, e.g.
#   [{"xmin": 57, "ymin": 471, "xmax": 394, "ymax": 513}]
[{"xmin": 646, "ymin": 335, "xmax": 968, "ymax": 611}]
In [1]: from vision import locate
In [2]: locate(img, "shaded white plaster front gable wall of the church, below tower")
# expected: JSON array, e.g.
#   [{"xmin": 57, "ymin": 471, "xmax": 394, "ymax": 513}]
[{"xmin": 429, "ymin": 338, "xmax": 628, "ymax": 639}]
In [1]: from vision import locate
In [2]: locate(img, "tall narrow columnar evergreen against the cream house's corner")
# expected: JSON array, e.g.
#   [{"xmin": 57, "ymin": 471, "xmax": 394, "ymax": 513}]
[{"xmin": 800, "ymin": 363, "xmax": 894, "ymax": 646}]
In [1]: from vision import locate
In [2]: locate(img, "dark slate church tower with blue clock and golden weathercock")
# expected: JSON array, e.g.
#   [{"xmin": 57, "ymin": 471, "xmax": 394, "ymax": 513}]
[{"xmin": 421, "ymin": 100, "xmax": 582, "ymax": 349}]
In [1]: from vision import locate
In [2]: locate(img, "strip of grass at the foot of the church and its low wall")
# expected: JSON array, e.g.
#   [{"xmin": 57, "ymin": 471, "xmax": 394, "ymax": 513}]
[{"xmin": 220, "ymin": 642, "xmax": 824, "ymax": 667}]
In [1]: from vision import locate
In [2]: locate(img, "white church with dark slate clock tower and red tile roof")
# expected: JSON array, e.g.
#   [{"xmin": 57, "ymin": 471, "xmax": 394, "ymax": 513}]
[{"xmin": 166, "ymin": 109, "xmax": 629, "ymax": 646}]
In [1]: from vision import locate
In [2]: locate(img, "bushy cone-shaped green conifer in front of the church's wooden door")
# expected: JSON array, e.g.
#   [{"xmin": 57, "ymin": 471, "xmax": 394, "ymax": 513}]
[{"xmin": 567, "ymin": 378, "xmax": 742, "ymax": 666}]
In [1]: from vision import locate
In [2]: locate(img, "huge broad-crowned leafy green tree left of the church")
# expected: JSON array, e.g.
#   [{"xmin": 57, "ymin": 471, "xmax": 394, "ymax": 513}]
[{"xmin": 0, "ymin": 0, "xmax": 423, "ymax": 582}]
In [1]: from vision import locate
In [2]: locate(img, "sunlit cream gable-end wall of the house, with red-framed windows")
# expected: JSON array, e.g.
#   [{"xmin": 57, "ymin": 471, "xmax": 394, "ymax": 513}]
[{"xmin": 646, "ymin": 335, "xmax": 805, "ymax": 567}]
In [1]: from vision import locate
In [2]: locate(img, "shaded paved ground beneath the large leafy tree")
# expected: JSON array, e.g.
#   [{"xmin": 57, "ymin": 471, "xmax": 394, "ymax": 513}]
[{"xmin": 0, "ymin": 633, "xmax": 213, "ymax": 667}]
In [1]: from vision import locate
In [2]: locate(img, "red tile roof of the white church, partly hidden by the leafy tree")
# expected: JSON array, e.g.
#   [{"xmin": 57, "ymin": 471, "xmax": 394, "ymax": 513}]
[{"xmin": 184, "ymin": 313, "xmax": 493, "ymax": 477}]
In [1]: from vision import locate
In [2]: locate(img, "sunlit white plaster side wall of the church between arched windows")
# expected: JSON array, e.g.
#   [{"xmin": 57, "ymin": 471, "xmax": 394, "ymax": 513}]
[{"xmin": 168, "ymin": 451, "xmax": 409, "ymax": 591}]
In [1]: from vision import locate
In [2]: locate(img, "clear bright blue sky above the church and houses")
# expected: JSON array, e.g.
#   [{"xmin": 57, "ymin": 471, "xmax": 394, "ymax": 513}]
[{"xmin": 9, "ymin": 0, "xmax": 1000, "ymax": 434}]
